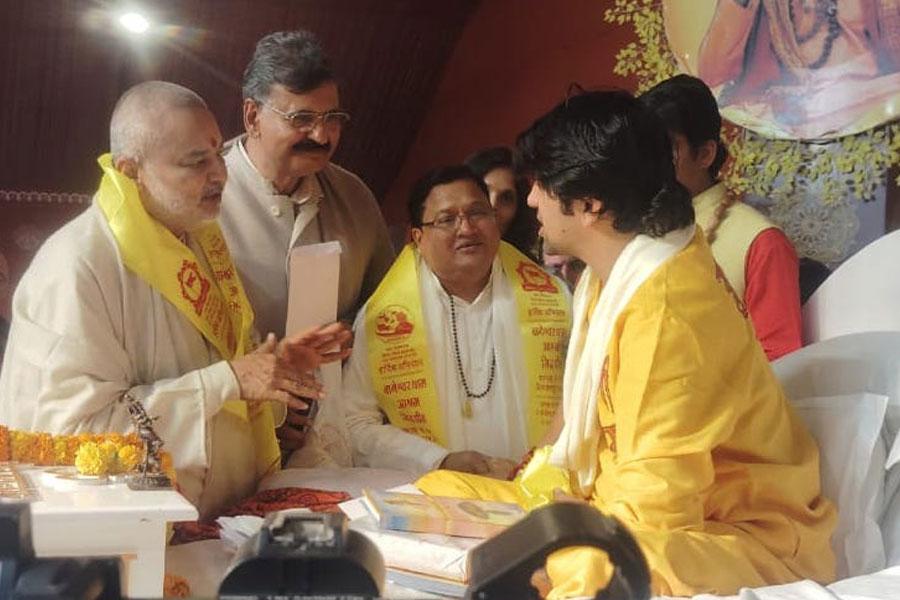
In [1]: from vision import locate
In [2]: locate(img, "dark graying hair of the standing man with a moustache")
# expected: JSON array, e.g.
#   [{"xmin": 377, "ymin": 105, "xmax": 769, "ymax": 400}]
[{"xmin": 243, "ymin": 29, "xmax": 334, "ymax": 102}]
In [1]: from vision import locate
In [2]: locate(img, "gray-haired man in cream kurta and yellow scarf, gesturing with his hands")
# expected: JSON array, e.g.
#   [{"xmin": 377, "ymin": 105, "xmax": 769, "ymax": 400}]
[{"xmin": 0, "ymin": 81, "xmax": 349, "ymax": 517}]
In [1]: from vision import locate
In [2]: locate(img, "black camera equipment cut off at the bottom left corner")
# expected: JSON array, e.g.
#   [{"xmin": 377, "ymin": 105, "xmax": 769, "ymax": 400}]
[{"xmin": 0, "ymin": 502, "xmax": 122, "ymax": 600}]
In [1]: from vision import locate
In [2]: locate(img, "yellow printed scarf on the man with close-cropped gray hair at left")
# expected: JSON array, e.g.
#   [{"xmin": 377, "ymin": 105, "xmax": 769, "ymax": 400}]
[{"xmin": 97, "ymin": 154, "xmax": 280, "ymax": 477}]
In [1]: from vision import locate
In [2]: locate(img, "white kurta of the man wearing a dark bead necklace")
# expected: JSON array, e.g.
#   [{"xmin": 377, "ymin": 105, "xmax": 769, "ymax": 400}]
[{"xmin": 343, "ymin": 259, "xmax": 527, "ymax": 475}]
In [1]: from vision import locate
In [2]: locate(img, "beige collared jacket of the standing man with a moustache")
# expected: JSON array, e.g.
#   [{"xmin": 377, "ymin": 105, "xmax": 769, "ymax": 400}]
[{"xmin": 219, "ymin": 138, "xmax": 394, "ymax": 337}]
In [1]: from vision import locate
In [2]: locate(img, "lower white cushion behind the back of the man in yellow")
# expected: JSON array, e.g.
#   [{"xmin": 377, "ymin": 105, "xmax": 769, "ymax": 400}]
[{"xmin": 773, "ymin": 332, "xmax": 900, "ymax": 577}]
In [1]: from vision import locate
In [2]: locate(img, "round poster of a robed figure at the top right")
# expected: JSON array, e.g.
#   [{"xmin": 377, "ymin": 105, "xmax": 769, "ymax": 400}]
[{"xmin": 663, "ymin": 0, "xmax": 900, "ymax": 140}]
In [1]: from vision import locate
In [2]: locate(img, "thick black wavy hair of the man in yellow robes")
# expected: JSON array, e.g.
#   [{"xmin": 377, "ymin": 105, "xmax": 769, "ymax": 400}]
[{"xmin": 516, "ymin": 90, "xmax": 694, "ymax": 237}]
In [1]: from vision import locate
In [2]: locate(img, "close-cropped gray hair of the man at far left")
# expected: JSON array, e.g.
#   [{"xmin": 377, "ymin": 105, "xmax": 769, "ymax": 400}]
[{"xmin": 109, "ymin": 81, "xmax": 207, "ymax": 160}]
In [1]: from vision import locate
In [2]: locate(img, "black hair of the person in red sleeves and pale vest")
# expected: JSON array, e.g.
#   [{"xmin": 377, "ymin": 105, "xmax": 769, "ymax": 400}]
[{"xmin": 639, "ymin": 74, "xmax": 728, "ymax": 179}]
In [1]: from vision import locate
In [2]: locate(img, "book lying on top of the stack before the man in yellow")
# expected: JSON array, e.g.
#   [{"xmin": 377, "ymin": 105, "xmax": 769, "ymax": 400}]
[{"xmin": 363, "ymin": 489, "xmax": 525, "ymax": 538}]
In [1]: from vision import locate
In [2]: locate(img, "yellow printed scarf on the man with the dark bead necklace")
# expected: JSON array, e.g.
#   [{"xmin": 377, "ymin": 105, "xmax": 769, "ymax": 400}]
[{"xmin": 365, "ymin": 242, "xmax": 571, "ymax": 447}]
